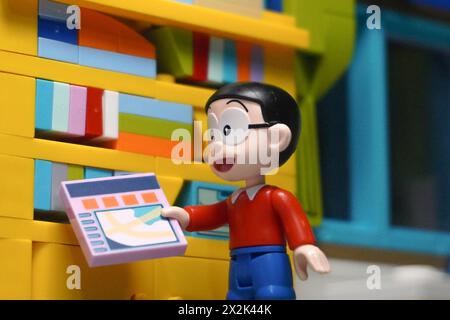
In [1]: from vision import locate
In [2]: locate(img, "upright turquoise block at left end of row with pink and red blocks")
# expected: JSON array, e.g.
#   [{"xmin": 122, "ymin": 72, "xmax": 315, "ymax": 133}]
[{"xmin": 35, "ymin": 79, "xmax": 53, "ymax": 130}]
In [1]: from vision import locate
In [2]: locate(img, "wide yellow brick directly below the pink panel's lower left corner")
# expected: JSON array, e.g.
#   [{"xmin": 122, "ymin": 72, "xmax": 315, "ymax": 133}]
[{"xmin": 32, "ymin": 243, "xmax": 156, "ymax": 299}]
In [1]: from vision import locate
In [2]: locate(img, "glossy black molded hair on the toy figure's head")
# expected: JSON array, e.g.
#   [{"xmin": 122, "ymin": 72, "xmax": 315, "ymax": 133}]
[{"xmin": 205, "ymin": 82, "xmax": 301, "ymax": 166}]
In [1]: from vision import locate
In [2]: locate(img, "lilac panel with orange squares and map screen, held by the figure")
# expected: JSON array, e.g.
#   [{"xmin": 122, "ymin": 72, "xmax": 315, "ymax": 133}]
[{"xmin": 61, "ymin": 174, "xmax": 187, "ymax": 267}]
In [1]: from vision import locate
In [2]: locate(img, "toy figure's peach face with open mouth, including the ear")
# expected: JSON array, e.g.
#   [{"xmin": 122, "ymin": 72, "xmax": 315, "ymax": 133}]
[{"xmin": 205, "ymin": 99, "xmax": 291, "ymax": 181}]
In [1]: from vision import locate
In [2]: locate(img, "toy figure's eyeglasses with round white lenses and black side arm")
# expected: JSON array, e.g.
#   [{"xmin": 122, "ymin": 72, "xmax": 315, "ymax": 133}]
[{"xmin": 208, "ymin": 107, "xmax": 278, "ymax": 145}]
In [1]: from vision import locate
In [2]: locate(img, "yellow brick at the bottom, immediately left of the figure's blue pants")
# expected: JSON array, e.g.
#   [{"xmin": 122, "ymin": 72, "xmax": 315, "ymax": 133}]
[{"xmin": 155, "ymin": 257, "xmax": 228, "ymax": 300}]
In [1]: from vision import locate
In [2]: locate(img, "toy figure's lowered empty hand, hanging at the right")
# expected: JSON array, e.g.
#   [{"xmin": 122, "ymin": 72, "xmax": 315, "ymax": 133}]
[{"xmin": 294, "ymin": 244, "xmax": 331, "ymax": 280}]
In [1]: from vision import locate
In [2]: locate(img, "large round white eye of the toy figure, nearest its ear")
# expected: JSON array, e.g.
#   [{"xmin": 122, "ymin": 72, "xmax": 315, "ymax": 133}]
[{"xmin": 219, "ymin": 108, "xmax": 249, "ymax": 145}]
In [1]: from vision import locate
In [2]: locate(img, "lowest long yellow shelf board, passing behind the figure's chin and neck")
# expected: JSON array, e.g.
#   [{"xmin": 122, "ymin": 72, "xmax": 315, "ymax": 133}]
[{"xmin": 0, "ymin": 134, "xmax": 295, "ymax": 192}]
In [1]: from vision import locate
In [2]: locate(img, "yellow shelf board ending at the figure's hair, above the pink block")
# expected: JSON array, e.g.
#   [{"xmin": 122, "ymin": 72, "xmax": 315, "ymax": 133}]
[{"xmin": 0, "ymin": 50, "xmax": 214, "ymax": 106}]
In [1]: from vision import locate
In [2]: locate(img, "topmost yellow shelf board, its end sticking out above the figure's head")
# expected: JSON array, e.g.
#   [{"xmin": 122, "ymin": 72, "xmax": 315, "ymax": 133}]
[{"xmin": 59, "ymin": 0, "xmax": 310, "ymax": 49}]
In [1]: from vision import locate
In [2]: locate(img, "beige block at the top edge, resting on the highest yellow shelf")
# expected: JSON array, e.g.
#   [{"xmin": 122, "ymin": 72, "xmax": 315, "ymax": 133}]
[{"xmin": 194, "ymin": 0, "xmax": 264, "ymax": 18}]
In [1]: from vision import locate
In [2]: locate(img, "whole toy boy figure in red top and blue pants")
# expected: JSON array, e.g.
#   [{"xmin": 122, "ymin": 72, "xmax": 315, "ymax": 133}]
[{"xmin": 162, "ymin": 82, "xmax": 330, "ymax": 300}]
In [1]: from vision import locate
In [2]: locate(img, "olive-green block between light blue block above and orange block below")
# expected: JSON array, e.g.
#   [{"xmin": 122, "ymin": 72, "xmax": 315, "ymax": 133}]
[{"xmin": 119, "ymin": 113, "xmax": 192, "ymax": 140}]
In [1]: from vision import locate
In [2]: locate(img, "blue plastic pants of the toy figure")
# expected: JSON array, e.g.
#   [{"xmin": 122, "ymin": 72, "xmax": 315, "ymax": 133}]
[{"xmin": 227, "ymin": 246, "xmax": 295, "ymax": 300}]
